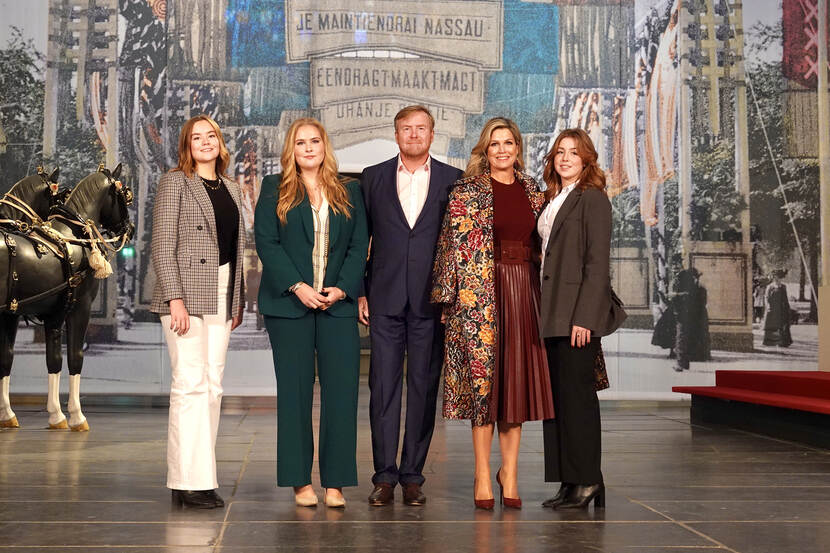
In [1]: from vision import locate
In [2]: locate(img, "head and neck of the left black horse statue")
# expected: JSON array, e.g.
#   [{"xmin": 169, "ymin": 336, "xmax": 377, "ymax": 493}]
[{"xmin": 0, "ymin": 167, "xmax": 64, "ymax": 233}]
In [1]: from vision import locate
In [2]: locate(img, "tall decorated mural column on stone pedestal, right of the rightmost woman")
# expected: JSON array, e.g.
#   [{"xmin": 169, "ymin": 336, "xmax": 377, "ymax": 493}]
[{"xmin": 677, "ymin": 0, "xmax": 753, "ymax": 351}]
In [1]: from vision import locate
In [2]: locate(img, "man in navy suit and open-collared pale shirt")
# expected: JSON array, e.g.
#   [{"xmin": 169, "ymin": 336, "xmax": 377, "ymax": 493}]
[{"xmin": 358, "ymin": 106, "xmax": 462, "ymax": 505}]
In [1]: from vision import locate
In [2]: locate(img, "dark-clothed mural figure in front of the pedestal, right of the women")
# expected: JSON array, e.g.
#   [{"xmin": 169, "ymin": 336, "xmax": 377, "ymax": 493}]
[{"xmin": 670, "ymin": 267, "xmax": 712, "ymax": 372}]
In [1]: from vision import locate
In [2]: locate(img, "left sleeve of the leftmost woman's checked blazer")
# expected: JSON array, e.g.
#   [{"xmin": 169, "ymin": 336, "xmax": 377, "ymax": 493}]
[{"xmin": 150, "ymin": 173, "xmax": 184, "ymax": 303}]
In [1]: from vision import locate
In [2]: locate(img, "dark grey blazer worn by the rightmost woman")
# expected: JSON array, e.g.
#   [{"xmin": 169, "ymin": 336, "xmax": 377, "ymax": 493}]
[{"xmin": 540, "ymin": 187, "xmax": 613, "ymax": 338}]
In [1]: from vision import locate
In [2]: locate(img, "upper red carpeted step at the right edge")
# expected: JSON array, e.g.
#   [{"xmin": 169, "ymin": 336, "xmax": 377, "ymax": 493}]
[{"xmin": 715, "ymin": 371, "xmax": 830, "ymax": 400}]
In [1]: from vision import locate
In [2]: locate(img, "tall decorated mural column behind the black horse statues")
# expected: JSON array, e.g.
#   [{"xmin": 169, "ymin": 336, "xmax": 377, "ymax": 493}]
[{"xmin": 43, "ymin": 0, "xmax": 119, "ymax": 341}]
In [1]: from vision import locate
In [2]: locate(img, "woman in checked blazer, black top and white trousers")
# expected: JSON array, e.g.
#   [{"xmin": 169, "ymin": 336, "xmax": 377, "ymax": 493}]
[{"xmin": 150, "ymin": 115, "xmax": 245, "ymax": 509}]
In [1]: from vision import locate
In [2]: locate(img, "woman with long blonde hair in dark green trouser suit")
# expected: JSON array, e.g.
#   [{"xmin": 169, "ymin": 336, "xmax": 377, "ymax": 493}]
[{"xmin": 254, "ymin": 118, "xmax": 369, "ymax": 507}]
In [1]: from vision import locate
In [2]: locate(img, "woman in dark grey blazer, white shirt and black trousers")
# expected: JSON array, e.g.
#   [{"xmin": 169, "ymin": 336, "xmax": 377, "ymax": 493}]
[{"xmin": 537, "ymin": 129, "xmax": 613, "ymax": 509}]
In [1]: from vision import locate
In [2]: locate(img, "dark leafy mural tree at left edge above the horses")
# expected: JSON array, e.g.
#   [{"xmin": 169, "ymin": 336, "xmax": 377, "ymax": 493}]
[{"xmin": 0, "ymin": 27, "xmax": 44, "ymax": 191}]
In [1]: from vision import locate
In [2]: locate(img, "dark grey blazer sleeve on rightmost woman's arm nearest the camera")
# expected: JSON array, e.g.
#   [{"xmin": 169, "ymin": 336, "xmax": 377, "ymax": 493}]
[{"xmin": 573, "ymin": 191, "xmax": 611, "ymax": 331}]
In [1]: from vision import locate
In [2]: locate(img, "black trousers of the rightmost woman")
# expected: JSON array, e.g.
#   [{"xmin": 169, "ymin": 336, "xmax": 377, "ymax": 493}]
[{"xmin": 542, "ymin": 336, "xmax": 602, "ymax": 485}]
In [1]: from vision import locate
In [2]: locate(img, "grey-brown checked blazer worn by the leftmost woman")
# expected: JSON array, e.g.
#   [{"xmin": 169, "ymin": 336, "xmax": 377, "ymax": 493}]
[{"xmin": 150, "ymin": 171, "xmax": 245, "ymax": 316}]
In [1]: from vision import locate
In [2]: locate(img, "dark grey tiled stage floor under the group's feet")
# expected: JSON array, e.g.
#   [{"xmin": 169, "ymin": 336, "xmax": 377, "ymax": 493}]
[{"xmin": 0, "ymin": 382, "xmax": 830, "ymax": 553}]
